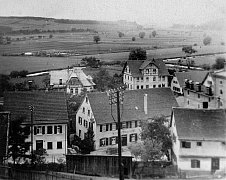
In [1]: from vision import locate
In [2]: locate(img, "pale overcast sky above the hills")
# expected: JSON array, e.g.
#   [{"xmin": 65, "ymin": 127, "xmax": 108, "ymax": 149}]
[{"xmin": 0, "ymin": 0, "xmax": 226, "ymax": 26}]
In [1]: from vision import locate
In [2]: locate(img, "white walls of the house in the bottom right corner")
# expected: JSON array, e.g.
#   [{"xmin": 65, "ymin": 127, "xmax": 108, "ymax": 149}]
[{"xmin": 170, "ymin": 116, "xmax": 226, "ymax": 175}]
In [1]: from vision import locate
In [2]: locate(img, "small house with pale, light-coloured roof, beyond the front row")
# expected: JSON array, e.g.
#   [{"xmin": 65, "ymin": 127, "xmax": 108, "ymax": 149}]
[{"xmin": 49, "ymin": 67, "xmax": 95, "ymax": 94}]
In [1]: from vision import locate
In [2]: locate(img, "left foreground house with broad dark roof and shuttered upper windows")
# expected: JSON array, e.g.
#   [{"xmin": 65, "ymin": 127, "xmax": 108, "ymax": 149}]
[{"xmin": 4, "ymin": 91, "xmax": 68, "ymax": 162}]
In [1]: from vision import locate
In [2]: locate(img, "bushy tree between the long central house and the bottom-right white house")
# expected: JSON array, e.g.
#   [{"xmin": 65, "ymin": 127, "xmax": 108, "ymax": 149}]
[{"xmin": 130, "ymin": 116, "xmax": 172, "ymax": 162}]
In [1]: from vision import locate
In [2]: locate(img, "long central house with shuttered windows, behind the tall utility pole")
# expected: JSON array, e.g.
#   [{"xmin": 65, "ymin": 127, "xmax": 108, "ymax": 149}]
[{"xmin": 74, "ymin": 88, "xmax": 178, "ymax": 150}]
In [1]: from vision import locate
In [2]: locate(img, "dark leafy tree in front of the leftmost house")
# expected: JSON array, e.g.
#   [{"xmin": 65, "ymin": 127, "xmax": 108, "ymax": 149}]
[{"xmin": 8, "ymin": 117, "xmax": 30, "ymax": 164}]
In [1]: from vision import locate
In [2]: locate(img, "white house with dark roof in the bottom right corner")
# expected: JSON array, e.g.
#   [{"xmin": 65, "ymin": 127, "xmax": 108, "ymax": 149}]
[{"xmin": 170, "ymin": 108, "xmax": 226, "ymax": 175}]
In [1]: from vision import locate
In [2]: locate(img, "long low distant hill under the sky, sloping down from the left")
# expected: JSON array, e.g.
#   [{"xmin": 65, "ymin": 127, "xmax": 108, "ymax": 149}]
[{"xmin": 0, "ymin": 16, "xmax": 143, "ymax": 34}]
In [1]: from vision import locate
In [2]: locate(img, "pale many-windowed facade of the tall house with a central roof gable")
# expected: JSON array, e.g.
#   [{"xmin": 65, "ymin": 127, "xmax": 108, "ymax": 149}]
[{"xmin": 123, "ymin": 63, "xmax": 168, "ymax": 90}]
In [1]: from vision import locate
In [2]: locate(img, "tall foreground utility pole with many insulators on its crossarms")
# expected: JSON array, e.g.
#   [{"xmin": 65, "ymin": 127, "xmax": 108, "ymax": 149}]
[{"xmin": 108, "ymin": 87, "xmax": 125, "ymax": 180}]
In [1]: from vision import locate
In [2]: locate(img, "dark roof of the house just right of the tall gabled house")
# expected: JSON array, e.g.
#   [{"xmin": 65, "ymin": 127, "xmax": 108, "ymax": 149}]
[{"xmin": 175, "ymin": 71, "xmax": 208, "ymax": 87}]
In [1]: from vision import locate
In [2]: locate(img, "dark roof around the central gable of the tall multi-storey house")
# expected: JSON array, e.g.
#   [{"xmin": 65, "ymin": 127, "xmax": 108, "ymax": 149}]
[{"xmin": 125, "ymin": 59, "xmax": 169, "ymax": 77}]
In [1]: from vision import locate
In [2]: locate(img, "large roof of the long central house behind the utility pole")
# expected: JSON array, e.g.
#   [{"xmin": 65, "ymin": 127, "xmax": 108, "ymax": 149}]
[{"xmin": 88, "ymin": 88, "xmax": 178, "ymax": 124}]
